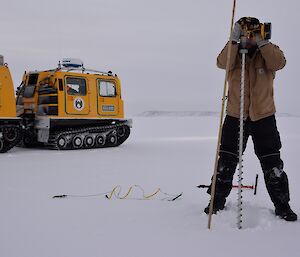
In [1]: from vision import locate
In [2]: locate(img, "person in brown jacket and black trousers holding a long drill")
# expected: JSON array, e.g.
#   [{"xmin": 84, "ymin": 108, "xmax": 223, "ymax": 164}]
[{"xmin": 204, "ymin": 17, "xmax": 297, "ymax": 221}]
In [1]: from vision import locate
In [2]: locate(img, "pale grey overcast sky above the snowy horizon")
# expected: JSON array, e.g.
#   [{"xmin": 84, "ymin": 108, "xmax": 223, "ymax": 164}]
[{"xmin": 0, "ymin": 0, "xmax": 300, "ymax": 114}]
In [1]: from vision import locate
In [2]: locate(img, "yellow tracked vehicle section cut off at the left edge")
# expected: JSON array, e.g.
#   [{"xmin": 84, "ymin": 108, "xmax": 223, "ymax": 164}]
[{"xmin": 0, "ymin": 55, "xmax": 22, "ymax": 153}]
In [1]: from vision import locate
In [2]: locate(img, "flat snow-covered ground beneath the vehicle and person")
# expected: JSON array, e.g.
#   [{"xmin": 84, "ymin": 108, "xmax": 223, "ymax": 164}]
[{"xmin": 0, "ymin": 112, "xmax": 300, "ymax": 257}]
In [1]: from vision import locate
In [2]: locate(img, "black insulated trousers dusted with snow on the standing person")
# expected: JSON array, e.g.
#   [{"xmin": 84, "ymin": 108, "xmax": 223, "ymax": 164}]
[{"xmin": 208, "ymin": 115, "xmax": 289, "ymax": 206}]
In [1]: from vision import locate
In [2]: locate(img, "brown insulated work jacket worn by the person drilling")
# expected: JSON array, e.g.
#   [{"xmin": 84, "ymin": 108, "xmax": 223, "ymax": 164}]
[{"xmin": 217, "ymin": 43, "xmax": 286, "ymax": 121}]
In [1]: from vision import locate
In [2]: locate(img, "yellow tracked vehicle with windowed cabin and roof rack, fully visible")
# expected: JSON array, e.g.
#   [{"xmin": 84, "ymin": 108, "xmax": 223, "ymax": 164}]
[{"xmin": 0, "ymin": 58, "xmax": 132, "ymax": 150}]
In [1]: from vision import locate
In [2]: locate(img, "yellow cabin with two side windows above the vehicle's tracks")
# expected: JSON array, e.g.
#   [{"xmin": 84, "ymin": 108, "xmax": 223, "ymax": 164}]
[{"xmin": 17, "ymin": 64, "xmax": 124, "ymax": 118}]
